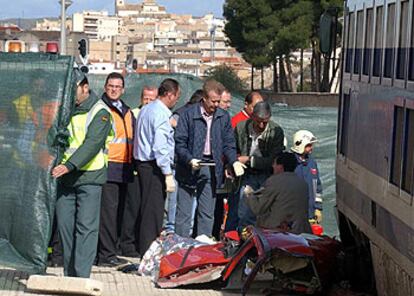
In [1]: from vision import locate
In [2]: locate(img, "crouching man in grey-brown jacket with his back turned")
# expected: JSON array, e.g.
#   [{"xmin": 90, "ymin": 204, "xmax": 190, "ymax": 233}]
[{"xmin": 246, "ymin": 152, "xmax": 312, "ymax": 234}]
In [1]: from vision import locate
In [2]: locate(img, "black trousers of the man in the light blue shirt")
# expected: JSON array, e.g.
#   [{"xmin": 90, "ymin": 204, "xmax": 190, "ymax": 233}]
[{"xmin": 137, "ymin": 161, "xmax": 166, "ymax": 256}]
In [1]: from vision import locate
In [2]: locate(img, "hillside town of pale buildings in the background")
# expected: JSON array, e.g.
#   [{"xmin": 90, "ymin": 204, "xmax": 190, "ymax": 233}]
[{"xmin": 0, "ymin": 0, "xmax": 250, "ymax": 77}]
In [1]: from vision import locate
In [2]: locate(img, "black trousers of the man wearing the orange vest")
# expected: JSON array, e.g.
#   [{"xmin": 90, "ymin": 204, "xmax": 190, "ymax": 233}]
[{"xmin": 98, "ymin": 182, "xmax": 128, "ymax": 261}]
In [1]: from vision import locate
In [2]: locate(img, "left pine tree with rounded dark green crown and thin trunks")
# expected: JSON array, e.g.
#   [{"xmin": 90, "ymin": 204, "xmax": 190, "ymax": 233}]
[{"xmin": 224, "ymin": 0, "xmax": 312, "ymax": 90}]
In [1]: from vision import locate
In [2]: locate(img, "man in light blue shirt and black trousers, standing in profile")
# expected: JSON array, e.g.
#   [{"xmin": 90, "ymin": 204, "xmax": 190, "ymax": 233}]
[{"xmin": 134, "ymin": 79, "xmax": 180, "ymax": 256}]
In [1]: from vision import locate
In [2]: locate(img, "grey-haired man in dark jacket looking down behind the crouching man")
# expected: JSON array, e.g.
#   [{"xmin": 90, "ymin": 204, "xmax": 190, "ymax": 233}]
[{"xmin": 233, "ymin": 101, "xmax": 284, "ymax": 230}]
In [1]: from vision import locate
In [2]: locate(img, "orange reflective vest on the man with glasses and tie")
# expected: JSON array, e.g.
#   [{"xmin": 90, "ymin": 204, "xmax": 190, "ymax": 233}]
[{"xmin": 108, "ymin": 109, "xmax": 134, "ymax": 163}]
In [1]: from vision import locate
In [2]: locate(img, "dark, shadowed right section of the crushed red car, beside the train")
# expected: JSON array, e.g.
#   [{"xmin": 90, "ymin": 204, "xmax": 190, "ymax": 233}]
[{"xmin": 223, "ymin": 226, "xmax": 339, "ymax": 295}]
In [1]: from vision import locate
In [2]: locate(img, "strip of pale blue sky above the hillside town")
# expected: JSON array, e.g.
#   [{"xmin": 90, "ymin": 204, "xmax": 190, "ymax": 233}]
[{"xmin": 0, "ymin": 0, "xmax": 224, "ymax": 19}]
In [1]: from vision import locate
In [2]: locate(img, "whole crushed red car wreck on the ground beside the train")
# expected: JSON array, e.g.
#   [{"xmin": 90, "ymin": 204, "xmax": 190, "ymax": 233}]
[{"xmin": 156, "ymin": 226, "xmax": 340, "ymax": 295}]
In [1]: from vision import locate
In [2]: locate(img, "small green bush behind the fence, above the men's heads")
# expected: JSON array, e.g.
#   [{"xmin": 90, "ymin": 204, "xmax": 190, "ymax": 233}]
[{"xmin": 207, "ymin": 65, "xmax": 247, "ymax": 93}]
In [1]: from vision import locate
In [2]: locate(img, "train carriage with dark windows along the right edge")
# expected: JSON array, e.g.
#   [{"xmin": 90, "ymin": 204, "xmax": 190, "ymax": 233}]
[{"xmin": 336, "ymin": 0, "xmax": 414, "ymax": 296}]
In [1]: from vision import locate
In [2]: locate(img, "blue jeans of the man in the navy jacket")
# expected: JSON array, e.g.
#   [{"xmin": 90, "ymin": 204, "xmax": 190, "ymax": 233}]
[{"xmin": 175, "ymin": 167, "xmax": 216, "ymax": 237}]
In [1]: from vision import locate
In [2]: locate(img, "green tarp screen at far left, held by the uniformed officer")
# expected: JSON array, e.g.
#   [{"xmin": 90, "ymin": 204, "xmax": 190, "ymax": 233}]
[{"xmin": 0, "ymin": 53, "xmax": 74, "ymax": 273}]
